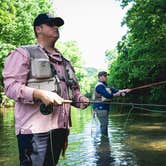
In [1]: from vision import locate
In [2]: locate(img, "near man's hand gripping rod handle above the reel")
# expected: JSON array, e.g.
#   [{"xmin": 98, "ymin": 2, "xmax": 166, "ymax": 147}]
[{"xmin": 33, "ymin": 89, "xmax": 64, "ymax": 105}]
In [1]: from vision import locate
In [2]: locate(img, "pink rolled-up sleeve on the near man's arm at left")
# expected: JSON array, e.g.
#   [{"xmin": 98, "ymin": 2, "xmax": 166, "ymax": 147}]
[{"xmin": 2, "ymin": 48, "xmax": 33, "ymax": 103}]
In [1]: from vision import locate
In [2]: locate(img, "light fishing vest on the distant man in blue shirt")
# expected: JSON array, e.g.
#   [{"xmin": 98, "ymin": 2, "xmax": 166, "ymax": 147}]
[{"xmin": 92, "ymin": 82, "xmax": 111, "ymax": 101}]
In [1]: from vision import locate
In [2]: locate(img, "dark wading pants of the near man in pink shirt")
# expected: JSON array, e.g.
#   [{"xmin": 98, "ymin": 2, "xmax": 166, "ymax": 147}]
[{"xmin": 17, "ymin": 129, "xmax": 69, "ymax": 166}]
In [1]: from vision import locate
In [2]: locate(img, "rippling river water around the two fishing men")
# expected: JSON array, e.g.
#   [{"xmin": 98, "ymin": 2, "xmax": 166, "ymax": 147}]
[{"xmin": 0, "ymin": 107, "xmax": 166, "ymax": 166}]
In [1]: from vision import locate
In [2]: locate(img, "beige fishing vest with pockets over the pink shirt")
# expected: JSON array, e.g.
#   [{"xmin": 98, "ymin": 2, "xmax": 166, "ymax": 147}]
[{"xmin": 22, "ymin": 45, "xmax": 78, "ymax": 99}]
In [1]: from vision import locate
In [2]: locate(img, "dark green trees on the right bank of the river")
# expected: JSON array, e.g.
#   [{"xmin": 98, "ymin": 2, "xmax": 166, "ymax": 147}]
[{"xmin": 107, "ymin": 0, "xmax": 166, "ymax": 103}]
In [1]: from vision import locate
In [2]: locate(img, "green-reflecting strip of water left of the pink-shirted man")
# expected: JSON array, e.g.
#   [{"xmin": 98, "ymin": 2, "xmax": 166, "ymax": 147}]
[{"xmin": 0, "ymin": 109, "xmax": 18, "ymax": 166}]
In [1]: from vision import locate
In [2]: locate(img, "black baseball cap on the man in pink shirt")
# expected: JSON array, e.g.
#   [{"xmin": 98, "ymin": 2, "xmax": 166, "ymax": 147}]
[{"xmin": 33, "ymin": 13, "xmax": 64, "ymax": 27}]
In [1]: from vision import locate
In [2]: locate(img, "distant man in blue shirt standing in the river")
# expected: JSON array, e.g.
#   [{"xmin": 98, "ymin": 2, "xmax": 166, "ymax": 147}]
[{"xmin": 93, "ymin": 71, "xmax": 129, "ymax": 136}]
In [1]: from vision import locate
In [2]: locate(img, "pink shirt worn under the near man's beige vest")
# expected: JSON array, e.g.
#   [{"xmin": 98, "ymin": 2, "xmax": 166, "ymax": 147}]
[{"xmin": 3, "ymin": 48, "xmax": 82, "ymax": 135}]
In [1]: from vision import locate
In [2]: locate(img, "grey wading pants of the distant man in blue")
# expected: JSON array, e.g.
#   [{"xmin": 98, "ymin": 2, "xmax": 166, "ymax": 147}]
[{"xmin": 95, "ymin": 110, "xmax": 108, "ymax": 136}]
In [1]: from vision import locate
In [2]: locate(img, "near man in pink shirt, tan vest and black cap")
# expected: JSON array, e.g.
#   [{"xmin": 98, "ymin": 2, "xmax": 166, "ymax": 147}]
[{"xmin": 3, "ymin": 13, "xmax": 89, "ymax": 166}]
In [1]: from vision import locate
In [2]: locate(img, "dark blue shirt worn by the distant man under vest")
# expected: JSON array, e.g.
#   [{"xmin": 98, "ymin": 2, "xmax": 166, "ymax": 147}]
[{"xmin": 93, "ymin": 82, "xmax": 119, "ymax": 110}]
